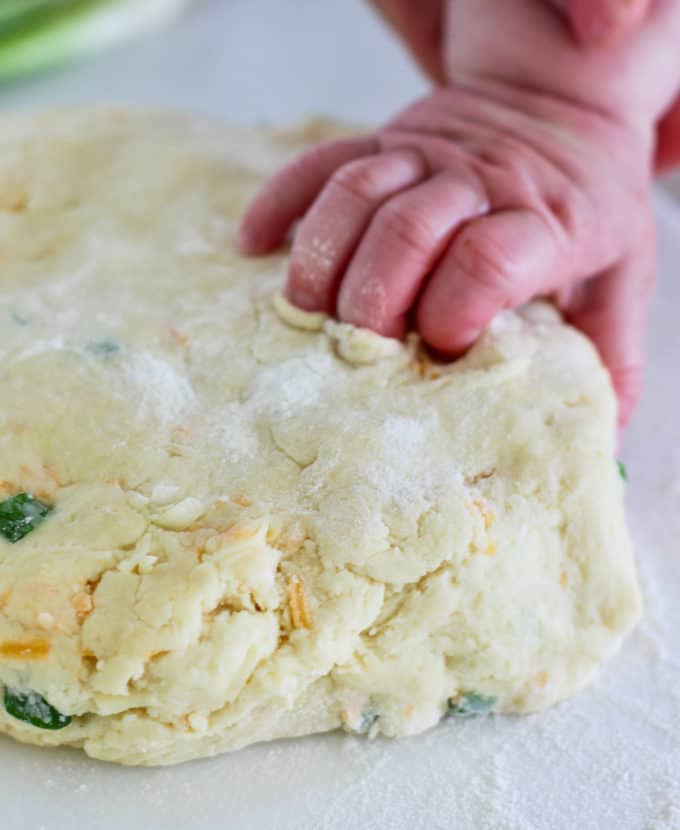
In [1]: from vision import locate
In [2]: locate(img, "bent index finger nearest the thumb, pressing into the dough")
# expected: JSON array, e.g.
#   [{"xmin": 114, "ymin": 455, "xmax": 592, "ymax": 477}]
[{"xmin": 417, "ymin": 210, "xmax": 567, "ymax": 356}]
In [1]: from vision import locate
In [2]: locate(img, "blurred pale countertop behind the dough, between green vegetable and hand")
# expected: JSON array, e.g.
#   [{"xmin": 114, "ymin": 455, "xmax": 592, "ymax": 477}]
[{"xmin": 0, "ymin": 0, "xmax": 427, "ymax": 123}]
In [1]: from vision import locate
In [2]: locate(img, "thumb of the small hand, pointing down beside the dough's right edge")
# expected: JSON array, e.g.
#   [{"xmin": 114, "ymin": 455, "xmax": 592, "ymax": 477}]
[{"xmin": 565, "ymin": 240, "xmax": 656, "ymax": 426}]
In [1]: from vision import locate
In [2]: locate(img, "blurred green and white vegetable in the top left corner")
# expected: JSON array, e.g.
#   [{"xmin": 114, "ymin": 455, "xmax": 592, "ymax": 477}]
[{"xmin": 0, "ymin": 0, "xmax": 197, "ymax": 80}]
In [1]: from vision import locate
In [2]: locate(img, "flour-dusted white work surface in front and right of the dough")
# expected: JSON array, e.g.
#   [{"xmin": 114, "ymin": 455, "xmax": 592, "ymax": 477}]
[{"xmin": 0, "ymin": 188, "xmax": 680, "ymax": 830}]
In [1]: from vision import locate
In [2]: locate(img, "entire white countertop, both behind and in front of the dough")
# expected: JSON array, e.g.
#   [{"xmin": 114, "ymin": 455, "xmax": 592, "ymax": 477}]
[{"xmin": 0, "ymin": 0, "xmax": 680, "ymax": 830}]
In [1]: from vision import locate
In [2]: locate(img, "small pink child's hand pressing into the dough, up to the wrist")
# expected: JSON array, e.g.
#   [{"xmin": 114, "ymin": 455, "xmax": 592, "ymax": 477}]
[{"xmin": 241, "ymin": 81, "xmax": 655, "ymax": 421}]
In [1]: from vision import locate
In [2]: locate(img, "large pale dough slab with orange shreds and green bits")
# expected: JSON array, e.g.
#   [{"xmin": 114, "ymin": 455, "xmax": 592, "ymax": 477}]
[{"xmin": 0, "ymin": 111, "xmax": 640, "ymax": 764}]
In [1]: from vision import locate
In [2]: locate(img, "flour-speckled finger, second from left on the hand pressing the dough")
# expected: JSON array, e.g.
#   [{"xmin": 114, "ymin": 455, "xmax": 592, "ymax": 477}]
[{"xmin": 286, "ymin": 150, "xmax": 427, "ymax": 313}]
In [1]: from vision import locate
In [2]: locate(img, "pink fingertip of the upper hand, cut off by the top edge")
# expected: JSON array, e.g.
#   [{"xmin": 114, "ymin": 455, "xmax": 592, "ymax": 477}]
[{"xmin": 563, "ymin": 0, "xmax": 651, "ymax": 44}]
